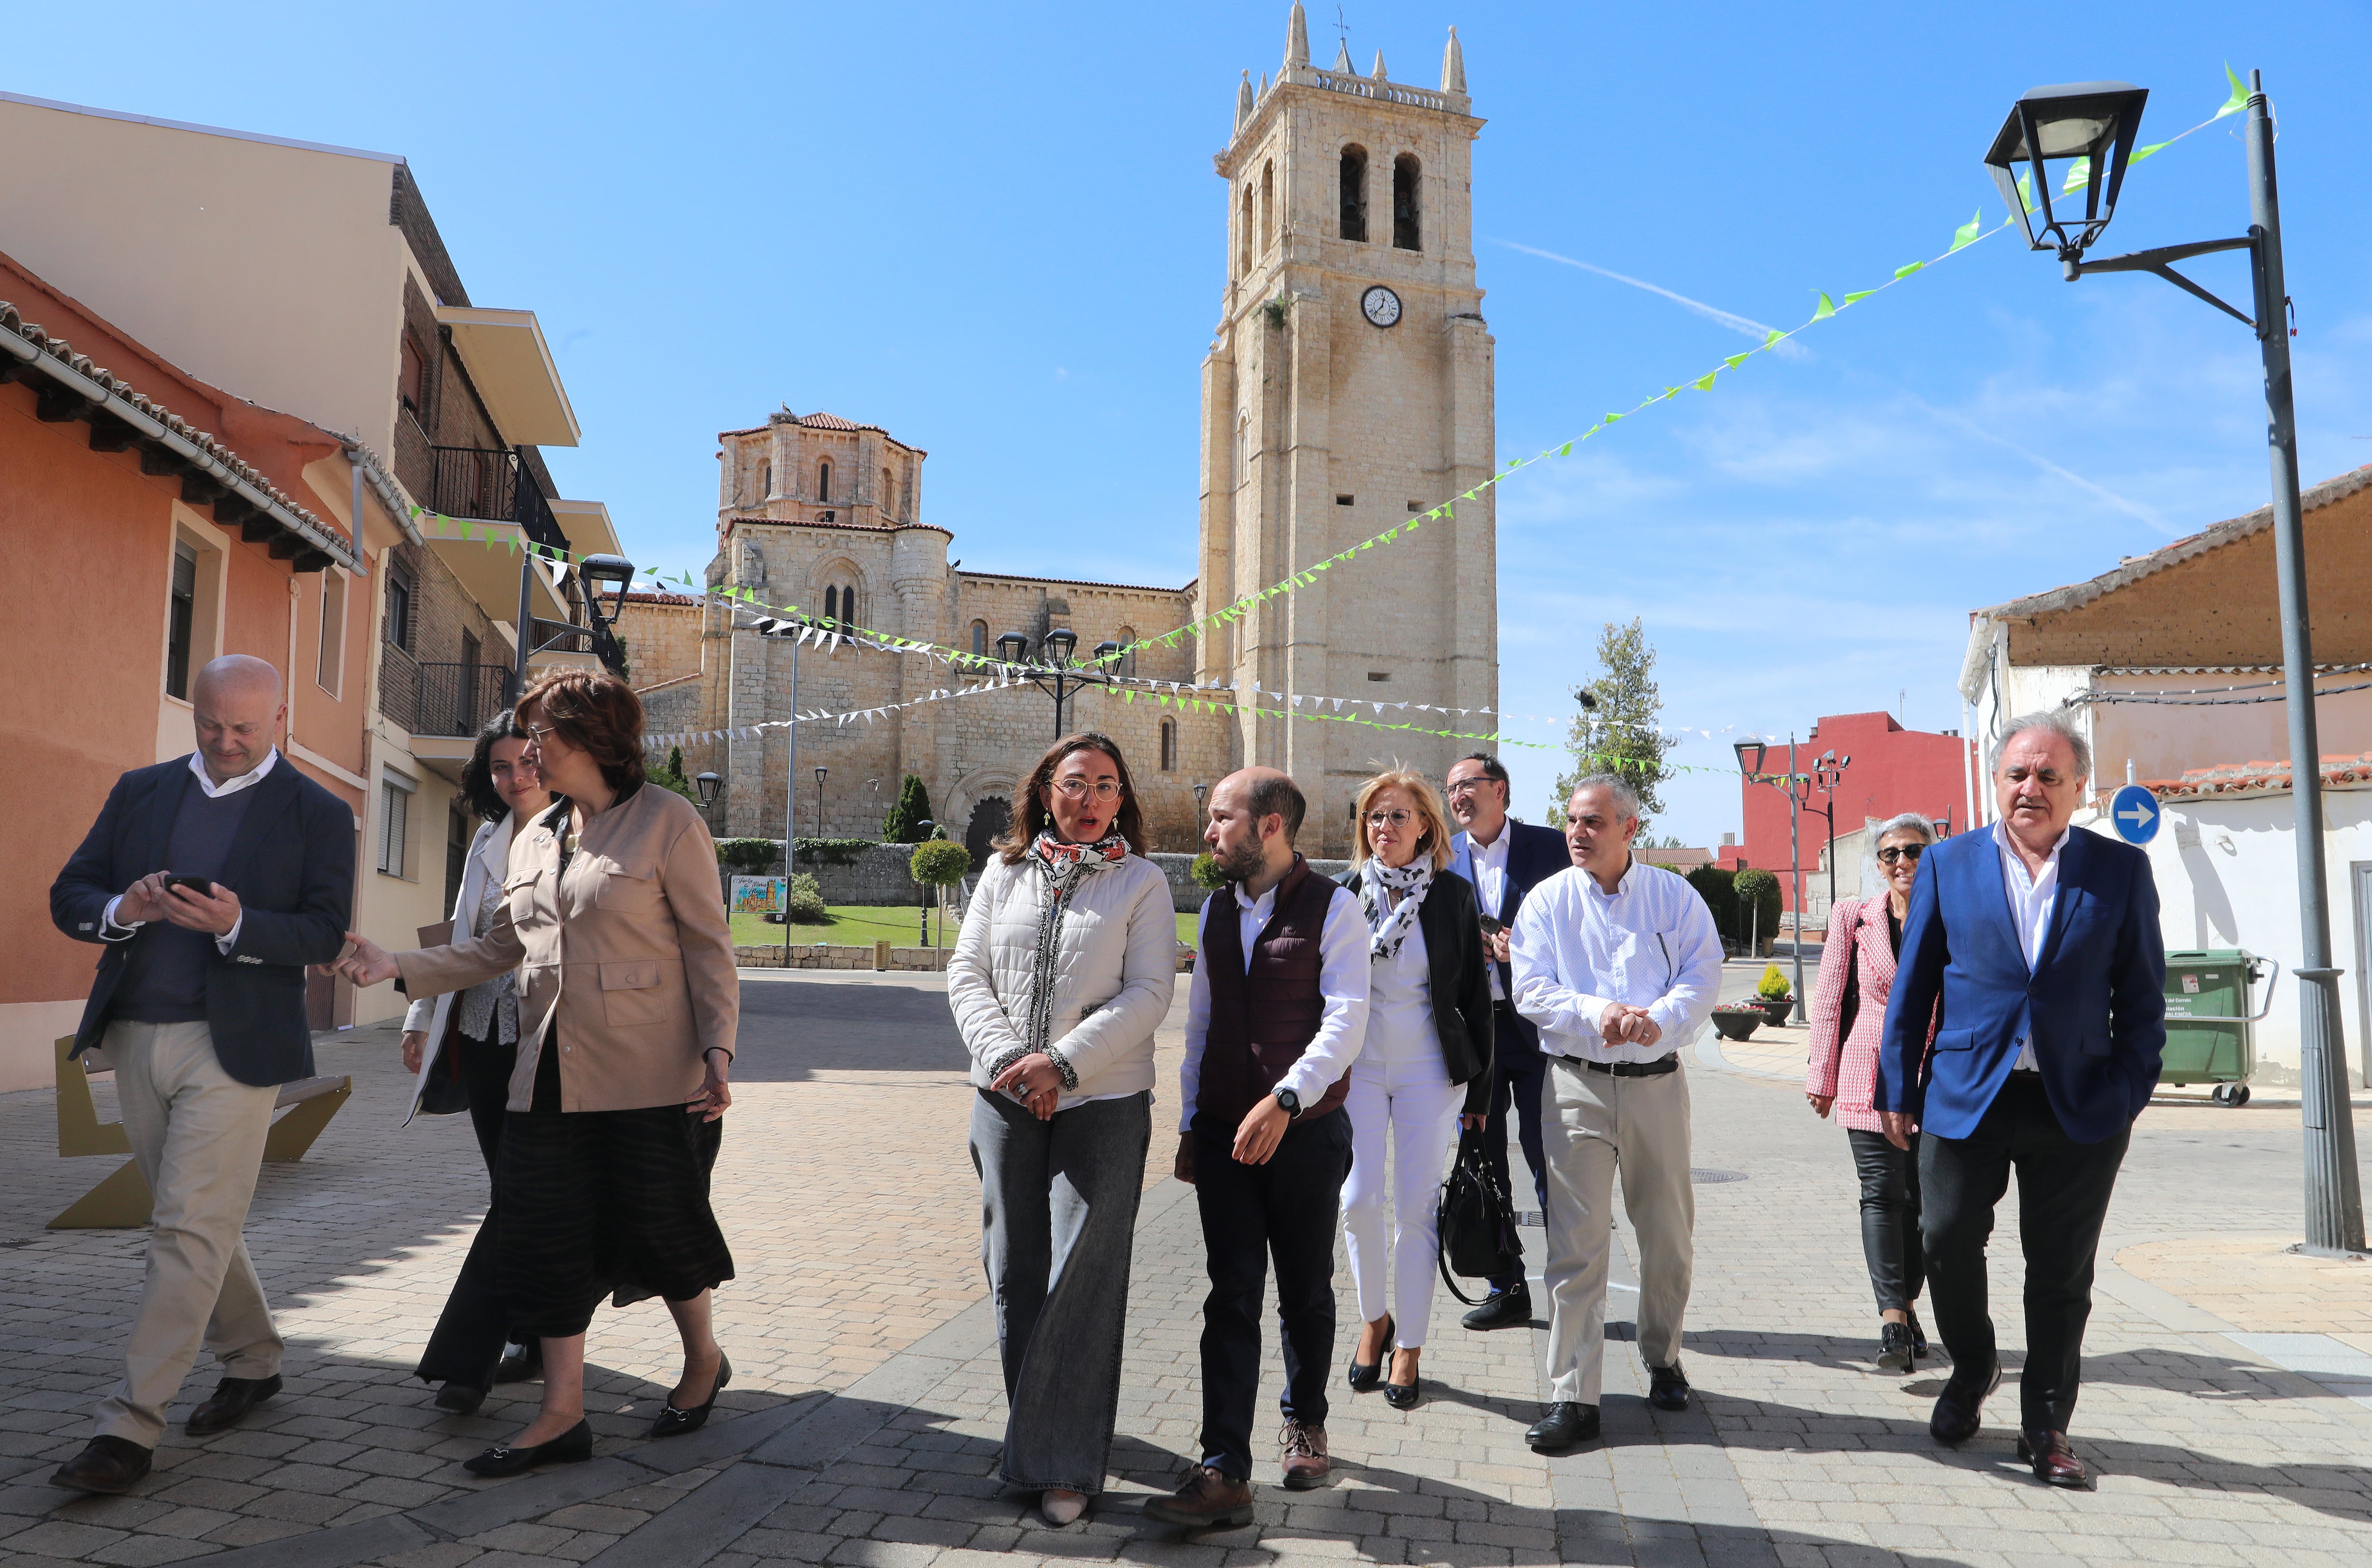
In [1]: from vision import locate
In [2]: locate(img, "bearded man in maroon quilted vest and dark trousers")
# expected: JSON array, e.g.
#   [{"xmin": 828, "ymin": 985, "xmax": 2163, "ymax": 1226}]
[{"xmin": 1146, "ymin": 769, "xmax": 1369, "ymax": 1530}]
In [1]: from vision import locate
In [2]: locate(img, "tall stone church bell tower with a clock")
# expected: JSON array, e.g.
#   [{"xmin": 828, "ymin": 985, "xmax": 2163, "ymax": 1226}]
[{"xmin": 1198, "ymin": 2, "xmax": 1499, "ymax": 854}]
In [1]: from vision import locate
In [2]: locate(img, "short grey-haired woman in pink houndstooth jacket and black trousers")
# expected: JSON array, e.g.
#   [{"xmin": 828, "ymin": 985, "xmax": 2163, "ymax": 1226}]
[{"xmin": 1803, "ymin": 811, "xmax": 1936, "ymax": 1373}]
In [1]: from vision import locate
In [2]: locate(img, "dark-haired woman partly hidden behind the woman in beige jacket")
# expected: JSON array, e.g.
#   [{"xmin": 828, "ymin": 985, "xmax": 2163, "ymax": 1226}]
[{"xmin": 403, "ymin": 709, "xmax": 553, "ymax": 1416}]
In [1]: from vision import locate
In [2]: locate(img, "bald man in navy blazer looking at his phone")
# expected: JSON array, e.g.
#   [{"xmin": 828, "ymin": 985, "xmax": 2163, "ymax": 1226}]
[{"xmin": 50, "ymin": 655, "xmax": 353, "ymax": 1492}]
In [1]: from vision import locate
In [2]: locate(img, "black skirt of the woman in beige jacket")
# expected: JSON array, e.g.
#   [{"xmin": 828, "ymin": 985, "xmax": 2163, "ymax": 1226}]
[{"xmin": 493, "ymin": 1034, "xmax": 733, "ymax": 1338}]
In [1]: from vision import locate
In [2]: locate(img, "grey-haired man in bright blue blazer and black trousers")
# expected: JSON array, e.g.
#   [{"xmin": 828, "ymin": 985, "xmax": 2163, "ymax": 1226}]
[{"xmin": 1874, "ymin": 714, "xmax": 2166, "ymax": 1487}]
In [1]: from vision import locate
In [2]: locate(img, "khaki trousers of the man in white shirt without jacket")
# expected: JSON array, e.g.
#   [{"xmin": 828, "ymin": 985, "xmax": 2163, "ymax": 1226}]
[{"xmin": 1539, "ymin": 1056, "xmax": 1696, "ymax": 1404}]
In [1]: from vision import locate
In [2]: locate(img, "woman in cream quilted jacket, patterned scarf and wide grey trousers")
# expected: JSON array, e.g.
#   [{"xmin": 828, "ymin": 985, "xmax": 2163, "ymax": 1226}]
[{"xmin": 946, "ymin": 731, "xmax": 1177, "ymax": 1525}]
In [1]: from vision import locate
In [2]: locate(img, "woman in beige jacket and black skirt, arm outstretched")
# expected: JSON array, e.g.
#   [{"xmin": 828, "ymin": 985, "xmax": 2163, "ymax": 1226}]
[{"xmin": 339, "ymin": 669, "xmax": 740, "ymax": 1475}]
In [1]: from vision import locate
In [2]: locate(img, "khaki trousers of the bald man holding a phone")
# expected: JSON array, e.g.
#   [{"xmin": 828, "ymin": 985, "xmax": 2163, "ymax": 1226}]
[{"xmin": 97, "ymin": 1020, "xmax": 282, "ymax": 1447}]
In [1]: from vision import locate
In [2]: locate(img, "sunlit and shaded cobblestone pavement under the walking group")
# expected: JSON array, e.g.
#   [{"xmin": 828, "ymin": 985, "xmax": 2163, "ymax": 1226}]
[{"xmin": 0, "ymin": 958, "xmax": 2372, "ymax": 1568}]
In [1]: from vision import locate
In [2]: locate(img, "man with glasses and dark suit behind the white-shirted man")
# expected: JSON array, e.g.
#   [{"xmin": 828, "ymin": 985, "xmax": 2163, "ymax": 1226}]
[{"xmin": 1447, "ymin": 752, "xmax": 1573, "ymax": 1328}]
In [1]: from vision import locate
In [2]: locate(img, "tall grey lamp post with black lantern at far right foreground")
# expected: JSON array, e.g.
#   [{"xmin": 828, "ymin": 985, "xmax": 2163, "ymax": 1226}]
[{"xmin": 1985, "ymin": 71, "xmax": 2365, "ymax": 1257}]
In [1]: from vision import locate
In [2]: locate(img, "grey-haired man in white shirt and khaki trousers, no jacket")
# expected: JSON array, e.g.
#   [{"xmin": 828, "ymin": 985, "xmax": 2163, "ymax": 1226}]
[{"xmin": 1513, "ymin": 773, "xmax": 1722, "ymax": 1452}]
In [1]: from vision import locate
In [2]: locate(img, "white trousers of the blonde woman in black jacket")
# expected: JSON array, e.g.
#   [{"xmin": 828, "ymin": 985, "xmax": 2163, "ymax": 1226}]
[{"xmin": 1343, "ymin": 1051, "xmax": 1466, "ymax": 1350}]
